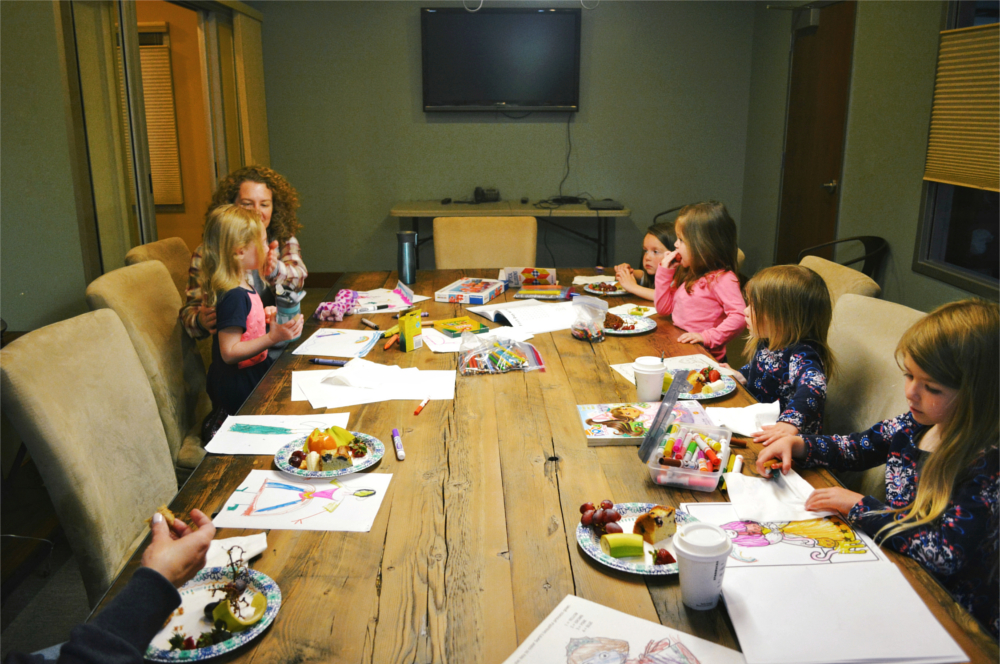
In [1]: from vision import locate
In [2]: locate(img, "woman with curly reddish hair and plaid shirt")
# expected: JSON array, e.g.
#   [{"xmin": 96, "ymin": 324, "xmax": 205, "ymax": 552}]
[{"xmin": 180, "ymin": 165, "xmax": 309, "ymax": 339}]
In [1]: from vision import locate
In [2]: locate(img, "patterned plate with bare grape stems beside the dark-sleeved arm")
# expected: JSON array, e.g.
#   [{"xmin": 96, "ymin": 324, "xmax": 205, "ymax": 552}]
[{"xmin": 146, "ymin": 566, "xmax": 281, "ymax": 662}]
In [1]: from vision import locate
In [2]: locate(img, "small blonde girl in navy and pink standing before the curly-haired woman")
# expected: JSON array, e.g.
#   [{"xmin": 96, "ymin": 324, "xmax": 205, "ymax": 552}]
[{"xmin": 199, "ymin": 204, "xmax": 302, "ymax": 420}]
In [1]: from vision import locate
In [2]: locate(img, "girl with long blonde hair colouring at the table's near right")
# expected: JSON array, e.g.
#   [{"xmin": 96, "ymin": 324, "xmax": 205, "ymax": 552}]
[{"xmin": 757, "ymin": 300, "xmax": 1000, "ymax": 636}]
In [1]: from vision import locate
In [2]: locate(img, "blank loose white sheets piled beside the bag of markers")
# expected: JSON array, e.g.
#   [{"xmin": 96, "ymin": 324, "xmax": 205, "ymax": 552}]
[{"xmin": 292, "ymin": 359, "xmax": 455, "ymax": 408}]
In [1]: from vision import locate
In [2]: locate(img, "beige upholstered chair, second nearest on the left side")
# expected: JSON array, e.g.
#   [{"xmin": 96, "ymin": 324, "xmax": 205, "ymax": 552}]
[{"xmin": 87, "ymin": 261, "xmax": 207, "ymax": 469}]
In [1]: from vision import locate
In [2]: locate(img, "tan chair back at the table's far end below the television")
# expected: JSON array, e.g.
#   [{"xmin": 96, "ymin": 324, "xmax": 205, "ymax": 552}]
[{"xmin": 434, "ymin": 217, "xmax": 538, "ymax": 270}]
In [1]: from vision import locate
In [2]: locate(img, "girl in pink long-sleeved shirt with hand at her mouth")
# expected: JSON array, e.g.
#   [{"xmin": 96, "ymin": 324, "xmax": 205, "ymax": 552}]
[{"xmin": 653, "ymin": 201, "xmax": 746, "ymax": 360}]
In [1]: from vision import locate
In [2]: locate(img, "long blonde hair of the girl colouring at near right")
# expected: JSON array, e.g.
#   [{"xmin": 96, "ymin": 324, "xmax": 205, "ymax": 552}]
[{"xmin": 877, "ymin": 300, "xmax": 1000, "ymax": 540}]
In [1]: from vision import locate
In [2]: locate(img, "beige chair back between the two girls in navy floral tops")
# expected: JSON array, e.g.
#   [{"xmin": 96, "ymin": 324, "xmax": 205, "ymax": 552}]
[{"xmin": 824, "ymin": 294, "xmax": 924, "ymax": 500}]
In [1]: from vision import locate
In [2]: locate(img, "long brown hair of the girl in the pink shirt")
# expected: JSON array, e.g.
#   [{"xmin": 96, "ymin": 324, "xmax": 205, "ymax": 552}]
[{"xmin": 673, "ymin": 201, "xmax": 739, "ymax": 293}]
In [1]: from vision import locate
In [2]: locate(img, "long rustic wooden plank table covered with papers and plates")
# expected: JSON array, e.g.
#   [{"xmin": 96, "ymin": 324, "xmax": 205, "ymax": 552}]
[{"xmin": 95, "ymin": 269, "xmax": 998, "ymax": 664}]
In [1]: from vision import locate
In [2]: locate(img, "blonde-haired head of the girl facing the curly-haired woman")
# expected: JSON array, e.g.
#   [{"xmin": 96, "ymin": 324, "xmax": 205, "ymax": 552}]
[{"xmin": 198, "ymin": 203, "xmax": 267, "ymax": 307}]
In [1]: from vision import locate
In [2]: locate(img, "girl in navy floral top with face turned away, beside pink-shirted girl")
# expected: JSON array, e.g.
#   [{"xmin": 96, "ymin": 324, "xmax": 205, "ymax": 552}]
[{"xmin": 736, "ymin": 265, "xmax": 833, "ymax": 444}]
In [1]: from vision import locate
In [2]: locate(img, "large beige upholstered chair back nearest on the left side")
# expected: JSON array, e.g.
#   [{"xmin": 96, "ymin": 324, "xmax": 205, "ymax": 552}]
[{"xmin": 0, "ymin": 309, "xmax": 177, "ymax": 606}]
